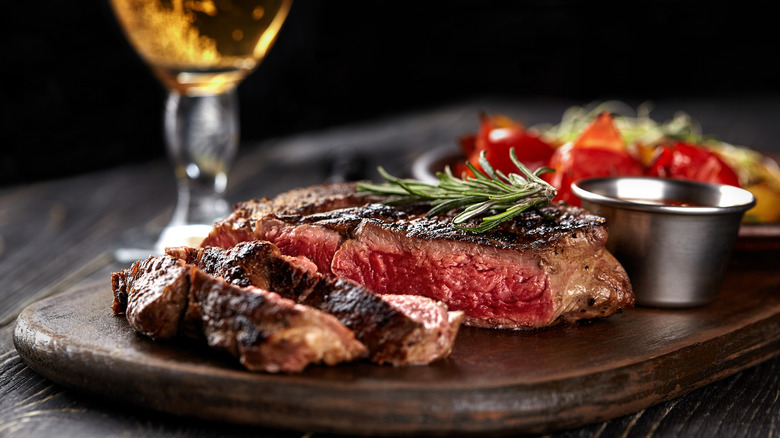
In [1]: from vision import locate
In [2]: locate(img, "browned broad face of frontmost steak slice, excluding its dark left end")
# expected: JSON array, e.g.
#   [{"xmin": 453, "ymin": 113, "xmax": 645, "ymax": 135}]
[{"xmin": 191, "ymin": 269, "xmax": 366, "ymax": 372}]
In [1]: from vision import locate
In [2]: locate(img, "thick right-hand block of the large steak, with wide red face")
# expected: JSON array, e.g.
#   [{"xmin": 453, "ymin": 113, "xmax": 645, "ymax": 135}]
[{"xmin": 331, "ymin": 209, "xmax": 633, "ymax": 328}]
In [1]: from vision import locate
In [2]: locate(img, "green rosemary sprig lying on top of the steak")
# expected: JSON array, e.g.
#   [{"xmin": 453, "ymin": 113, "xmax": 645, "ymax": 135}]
[{"xmin": 358, "ymin": 148, "xmax": 558, "ymax": 233}]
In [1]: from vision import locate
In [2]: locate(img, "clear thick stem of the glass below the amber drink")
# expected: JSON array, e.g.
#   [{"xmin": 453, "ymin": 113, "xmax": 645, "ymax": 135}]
[{"xmin": 165, "ymin": 89, "xmax": 239, "ymax": 227}]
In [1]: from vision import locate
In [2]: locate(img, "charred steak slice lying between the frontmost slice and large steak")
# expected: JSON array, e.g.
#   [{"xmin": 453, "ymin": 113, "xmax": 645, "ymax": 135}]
[{"xmin": 167, "ymin": 240, "xmax": 463, "ymax": 366}]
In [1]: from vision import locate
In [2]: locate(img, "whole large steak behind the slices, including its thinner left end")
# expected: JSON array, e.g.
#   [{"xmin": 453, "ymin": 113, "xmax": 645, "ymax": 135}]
[{"xmin": 201, "ymin": 183, "xmax": 634, "ymax": 329}]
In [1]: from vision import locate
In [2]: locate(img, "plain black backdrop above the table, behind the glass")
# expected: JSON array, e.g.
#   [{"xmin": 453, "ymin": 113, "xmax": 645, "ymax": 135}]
[{"xmin": 0, "ymin": 0, "xmax": 778, "ymax": 185}]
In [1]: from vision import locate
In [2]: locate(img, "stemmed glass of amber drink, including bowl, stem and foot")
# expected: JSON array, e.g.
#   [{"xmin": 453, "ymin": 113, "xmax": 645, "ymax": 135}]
[{"xmin": 110, "ymin": 0, "xmax": 291, "ymax": 259}]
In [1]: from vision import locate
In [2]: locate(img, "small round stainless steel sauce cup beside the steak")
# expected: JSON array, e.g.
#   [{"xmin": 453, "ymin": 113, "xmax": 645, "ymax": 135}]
[{"xmin": 572, "ymin": 177, "xmax": 756, "ymax": 308}]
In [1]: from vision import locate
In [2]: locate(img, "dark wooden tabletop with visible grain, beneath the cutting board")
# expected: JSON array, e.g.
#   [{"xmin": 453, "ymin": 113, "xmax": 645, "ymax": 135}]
[{"xmin": 0, "ymin": 97, "xmax": 780, "ymax": 437}]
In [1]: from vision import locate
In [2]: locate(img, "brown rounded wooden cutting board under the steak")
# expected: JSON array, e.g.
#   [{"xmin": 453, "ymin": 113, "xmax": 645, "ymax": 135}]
[{"xmin": 14, "ymin": 264, "xmax": 780, "ymax": 435}]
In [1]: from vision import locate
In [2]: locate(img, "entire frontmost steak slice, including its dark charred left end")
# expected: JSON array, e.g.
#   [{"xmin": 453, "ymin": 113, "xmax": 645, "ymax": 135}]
[{"xmin": 111, "ymin": 256, "xmax": 367, "ymax": 372}]
